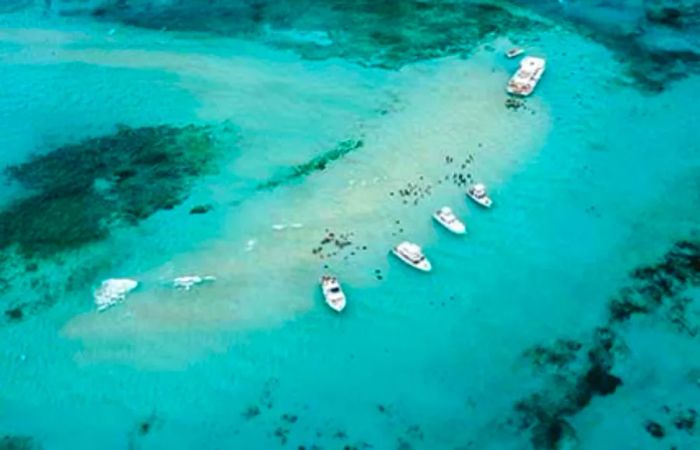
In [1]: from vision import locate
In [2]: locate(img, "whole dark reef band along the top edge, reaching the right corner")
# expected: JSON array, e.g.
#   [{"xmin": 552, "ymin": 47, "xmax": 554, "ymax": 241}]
[{"xmin": 41, "ymin": 0, "xmax": 700, "ymax": 92}]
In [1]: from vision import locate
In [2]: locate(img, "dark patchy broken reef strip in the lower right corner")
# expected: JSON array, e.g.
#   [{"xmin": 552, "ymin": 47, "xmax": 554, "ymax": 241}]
[{"xmin": 511, "ymin": 241, "xmax": 700, "ymax": 449}]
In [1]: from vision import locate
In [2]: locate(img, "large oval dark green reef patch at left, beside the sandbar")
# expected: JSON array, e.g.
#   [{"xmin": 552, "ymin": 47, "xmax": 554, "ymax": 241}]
[{"xmin": 0, "ymin": 123, "xmax": 236, "ymax": 324}]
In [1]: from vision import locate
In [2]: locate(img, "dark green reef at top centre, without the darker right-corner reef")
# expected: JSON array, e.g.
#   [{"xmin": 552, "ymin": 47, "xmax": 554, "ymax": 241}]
[{"xmin": 53, "ymin": 0, "xmax": 548, "ymax": 69}]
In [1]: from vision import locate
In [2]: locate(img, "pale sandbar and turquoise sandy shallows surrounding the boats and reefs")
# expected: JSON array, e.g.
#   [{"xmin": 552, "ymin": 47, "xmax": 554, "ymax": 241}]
[{"xmin": 0, "ymin": 3, "xmax": 700, "ymax": 449}]
